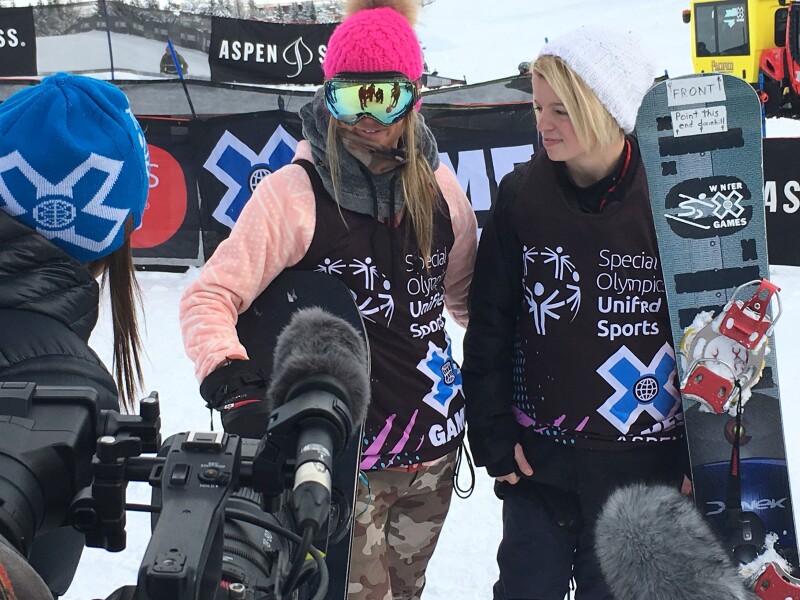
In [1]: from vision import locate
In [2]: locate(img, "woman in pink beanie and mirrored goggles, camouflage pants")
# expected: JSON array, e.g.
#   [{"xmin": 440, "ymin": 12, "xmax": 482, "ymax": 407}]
[{"xmin": 181, "ymin": 0, "xmax": 477, "ymax": 600}]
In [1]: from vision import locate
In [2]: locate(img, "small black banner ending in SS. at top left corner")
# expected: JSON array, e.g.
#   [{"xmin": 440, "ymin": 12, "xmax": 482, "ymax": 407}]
[{"xmin": 0, "ymin": 6, "xmax": 38, "ymax": 77}]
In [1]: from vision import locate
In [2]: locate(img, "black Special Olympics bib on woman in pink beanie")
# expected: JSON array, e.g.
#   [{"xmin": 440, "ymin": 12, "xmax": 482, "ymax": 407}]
[{"xmin": 293, "ymin": 161, "xmax": 465, "ymax": 469}]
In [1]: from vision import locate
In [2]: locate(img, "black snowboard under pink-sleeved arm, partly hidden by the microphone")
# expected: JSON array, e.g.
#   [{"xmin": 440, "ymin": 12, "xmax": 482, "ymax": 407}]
[{"xmin": 236, "ymin": 270, "xmax": 369, "ymax": 600}]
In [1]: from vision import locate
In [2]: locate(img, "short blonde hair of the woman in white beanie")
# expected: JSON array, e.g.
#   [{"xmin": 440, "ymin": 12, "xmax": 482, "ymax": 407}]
[{"xmin": 531, "ymin": 55, "xmax": 625, "ymax": 150}]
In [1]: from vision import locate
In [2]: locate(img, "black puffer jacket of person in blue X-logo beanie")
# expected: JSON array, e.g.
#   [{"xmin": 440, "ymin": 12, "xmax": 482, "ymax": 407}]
[{"xmin": 0, "ymin": 210, "xmax": 118, "ymax": 409}]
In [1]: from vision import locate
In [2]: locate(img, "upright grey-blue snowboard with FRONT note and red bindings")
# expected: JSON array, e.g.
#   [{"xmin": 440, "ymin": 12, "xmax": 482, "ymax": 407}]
[{"xmin": 636, "ymin": 73, "xmax": 797, "ymax": 566}]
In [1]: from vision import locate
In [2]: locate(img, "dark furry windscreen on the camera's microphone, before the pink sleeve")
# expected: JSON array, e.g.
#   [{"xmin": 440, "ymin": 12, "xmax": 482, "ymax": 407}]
[{"xmin": 267, "ymin": 307, "xmax": 370, "ymax": 424}]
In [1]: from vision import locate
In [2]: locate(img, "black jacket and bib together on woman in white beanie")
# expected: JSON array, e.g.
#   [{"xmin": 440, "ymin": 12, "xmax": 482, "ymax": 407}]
[{"xmin": 464, "ymin": 138, "xmax": 683, "ymax": 460}]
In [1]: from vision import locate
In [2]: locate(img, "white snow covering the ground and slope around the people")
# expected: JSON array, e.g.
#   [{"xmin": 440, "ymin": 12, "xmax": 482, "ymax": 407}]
[{"xmin": 37, "ymin": 0, "xmax": 800, "ymax": 600}]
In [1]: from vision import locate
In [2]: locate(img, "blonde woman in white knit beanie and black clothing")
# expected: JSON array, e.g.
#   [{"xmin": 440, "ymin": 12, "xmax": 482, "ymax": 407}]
[{"xmin": 464, "ymin": 27, "xmax": 688, "ymax": 600}]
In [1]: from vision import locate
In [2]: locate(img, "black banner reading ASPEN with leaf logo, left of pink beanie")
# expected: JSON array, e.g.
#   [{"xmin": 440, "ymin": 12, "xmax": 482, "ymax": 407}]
[{"xmin": 208, "ymin": 17, "xmax": 336, "ymax": 84}]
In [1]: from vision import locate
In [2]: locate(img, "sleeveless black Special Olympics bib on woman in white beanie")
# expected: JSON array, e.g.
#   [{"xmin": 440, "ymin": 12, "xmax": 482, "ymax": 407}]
[{"xmin": 511, "ymin": 145, "xmax": 681, "ymax": 446}]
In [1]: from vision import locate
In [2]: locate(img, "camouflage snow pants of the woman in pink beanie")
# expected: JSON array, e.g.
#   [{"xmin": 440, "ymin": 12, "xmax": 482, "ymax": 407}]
[{"xmin": 347, "ymin": 453, "xmax": 455, "ymax": 600}]
